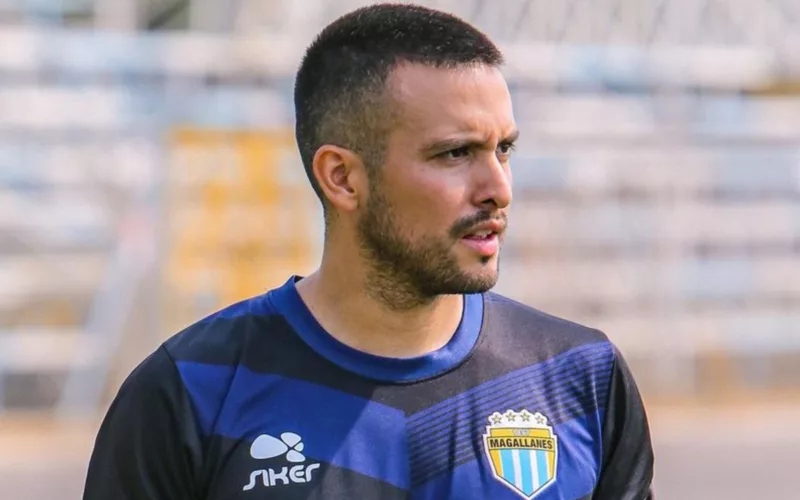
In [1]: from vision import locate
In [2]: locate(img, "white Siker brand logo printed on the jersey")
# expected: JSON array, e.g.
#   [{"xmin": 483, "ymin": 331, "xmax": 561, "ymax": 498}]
[{"xmin": 242, "ymin": 432, "xmax": 319, "ymax": 491}]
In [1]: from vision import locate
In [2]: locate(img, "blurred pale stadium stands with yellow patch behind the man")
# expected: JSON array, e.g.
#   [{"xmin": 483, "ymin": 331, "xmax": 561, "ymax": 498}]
[{"xmin": 0, "ymin": 0, "xmax": 800, "ymax": 500}]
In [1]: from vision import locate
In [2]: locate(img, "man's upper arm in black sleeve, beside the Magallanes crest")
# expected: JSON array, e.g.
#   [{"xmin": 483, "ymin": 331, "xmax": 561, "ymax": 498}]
[{"xmin": 592, "ymin": 349, "xmax": 654, "ymax": 500}]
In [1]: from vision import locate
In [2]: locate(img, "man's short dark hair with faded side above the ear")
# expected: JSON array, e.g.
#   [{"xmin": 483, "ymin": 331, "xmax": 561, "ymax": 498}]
[{"xmin": 294, "ymin": 4, "xmax": 503, "ymax": 206}]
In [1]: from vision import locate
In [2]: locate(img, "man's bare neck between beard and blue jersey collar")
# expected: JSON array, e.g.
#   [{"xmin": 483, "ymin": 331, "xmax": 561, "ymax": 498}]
[{"xmin": 297, "ymin": 250, "xmax": 464, "ymax": 358}]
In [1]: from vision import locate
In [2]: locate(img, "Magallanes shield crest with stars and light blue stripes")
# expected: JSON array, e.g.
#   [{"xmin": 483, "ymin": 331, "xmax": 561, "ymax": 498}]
[{"xmin": 483, "ymin": 410, "xmax": 558, "ymax": 500}]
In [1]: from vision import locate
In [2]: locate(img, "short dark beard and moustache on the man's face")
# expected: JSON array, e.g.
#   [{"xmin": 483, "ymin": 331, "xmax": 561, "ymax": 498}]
[{"xmin": 358, "ymin": 187, "xmax": 497, "ymax": 310}]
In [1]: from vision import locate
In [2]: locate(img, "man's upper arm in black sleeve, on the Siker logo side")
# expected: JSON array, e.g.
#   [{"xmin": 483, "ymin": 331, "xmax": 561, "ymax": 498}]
[{"xmin": 83, "ymin": 347, "xmax": 201, "ymax": 500}]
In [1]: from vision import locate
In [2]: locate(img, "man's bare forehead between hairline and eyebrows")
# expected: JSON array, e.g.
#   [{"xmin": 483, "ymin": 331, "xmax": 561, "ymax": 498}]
[{"xmin": 387, "ymin": 64, "xmax": 515, "ymax": 139}]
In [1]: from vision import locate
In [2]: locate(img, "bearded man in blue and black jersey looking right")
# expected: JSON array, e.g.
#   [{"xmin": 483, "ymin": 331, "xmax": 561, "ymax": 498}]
[{"xmin": 84, "ymin": 5, "xmax": 653, "ymax": 500}]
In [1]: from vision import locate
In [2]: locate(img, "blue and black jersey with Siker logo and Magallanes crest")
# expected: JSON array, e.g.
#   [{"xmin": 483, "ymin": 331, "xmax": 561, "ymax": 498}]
[{"xmin": 84, "ymin": 277, "xmax": 653, "ymax": 500}]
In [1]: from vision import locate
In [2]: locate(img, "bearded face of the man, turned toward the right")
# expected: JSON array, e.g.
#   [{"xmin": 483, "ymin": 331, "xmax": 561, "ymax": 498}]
[{"xmin": 358, "ymin": 64, "xmax": 517, "ymax": 300}]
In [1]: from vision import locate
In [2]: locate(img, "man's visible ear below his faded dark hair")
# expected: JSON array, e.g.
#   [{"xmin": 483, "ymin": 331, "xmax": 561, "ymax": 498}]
[{"xmin": 312, "ymin": 144, "xmax": 368, "ymax": 212}]
